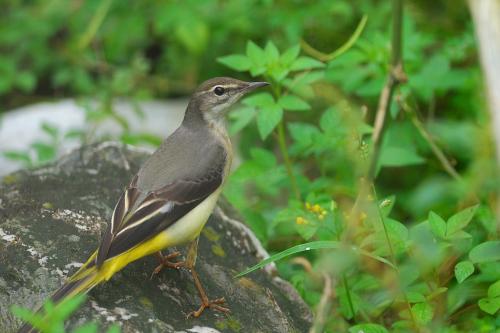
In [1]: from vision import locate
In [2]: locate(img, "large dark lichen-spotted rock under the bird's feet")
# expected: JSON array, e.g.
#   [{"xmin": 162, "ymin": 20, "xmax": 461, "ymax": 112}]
[{"xmin": 0, "ymin": 143, "xmax": 311, "ymax": 333}]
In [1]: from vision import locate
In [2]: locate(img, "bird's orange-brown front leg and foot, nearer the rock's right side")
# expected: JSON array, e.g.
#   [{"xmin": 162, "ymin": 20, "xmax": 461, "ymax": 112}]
[{"xmin": 185, "ymin": 237, "xmax": 230, "ymax": 318}]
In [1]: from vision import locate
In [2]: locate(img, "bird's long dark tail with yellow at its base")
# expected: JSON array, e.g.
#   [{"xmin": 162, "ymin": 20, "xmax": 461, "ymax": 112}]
[{"xmin": 18, "ymin": 253, "xmax": 104, "ymax": 333}]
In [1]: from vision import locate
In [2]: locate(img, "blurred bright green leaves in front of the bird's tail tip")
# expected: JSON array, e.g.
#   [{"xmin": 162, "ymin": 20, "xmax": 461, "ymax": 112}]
[{"xmin": 12, "ymin": 295, "xmax": 120, "ymax": 333}]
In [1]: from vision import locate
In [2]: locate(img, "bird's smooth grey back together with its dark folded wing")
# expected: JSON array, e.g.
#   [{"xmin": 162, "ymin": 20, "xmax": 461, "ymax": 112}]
[{"xmin": 96, "ymin": 127, "xmax": 227, "ymax": 267}]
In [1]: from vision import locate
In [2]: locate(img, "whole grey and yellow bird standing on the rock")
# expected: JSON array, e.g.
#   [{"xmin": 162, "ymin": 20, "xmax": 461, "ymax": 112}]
[{"xmin": 19, "ymin": 77, "xmax": 268, "ymax": 332}]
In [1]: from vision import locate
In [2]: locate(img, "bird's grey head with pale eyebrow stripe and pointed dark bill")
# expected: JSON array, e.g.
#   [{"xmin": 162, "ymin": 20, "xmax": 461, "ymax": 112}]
[{"xmin": 190, "ymin": 77, "xmax": 269, "ymax": 121}]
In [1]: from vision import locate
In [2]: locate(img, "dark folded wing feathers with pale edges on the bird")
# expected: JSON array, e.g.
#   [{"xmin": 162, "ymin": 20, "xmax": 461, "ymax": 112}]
[{"xmin": 96, "ymin": 148, "xmax": 226, "ymax": 267}]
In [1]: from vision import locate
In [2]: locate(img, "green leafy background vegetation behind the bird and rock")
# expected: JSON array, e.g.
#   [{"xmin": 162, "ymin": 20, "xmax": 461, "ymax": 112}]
[{"xmin": 0, "ymin": 0, "xmax": 500, "ymax": 333}]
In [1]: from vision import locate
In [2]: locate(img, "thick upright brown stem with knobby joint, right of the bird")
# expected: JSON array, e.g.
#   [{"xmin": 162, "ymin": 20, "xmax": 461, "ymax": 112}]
[{"xmin": 367, "ymin": 0, "xmax": 407, "ymax": 182}]
